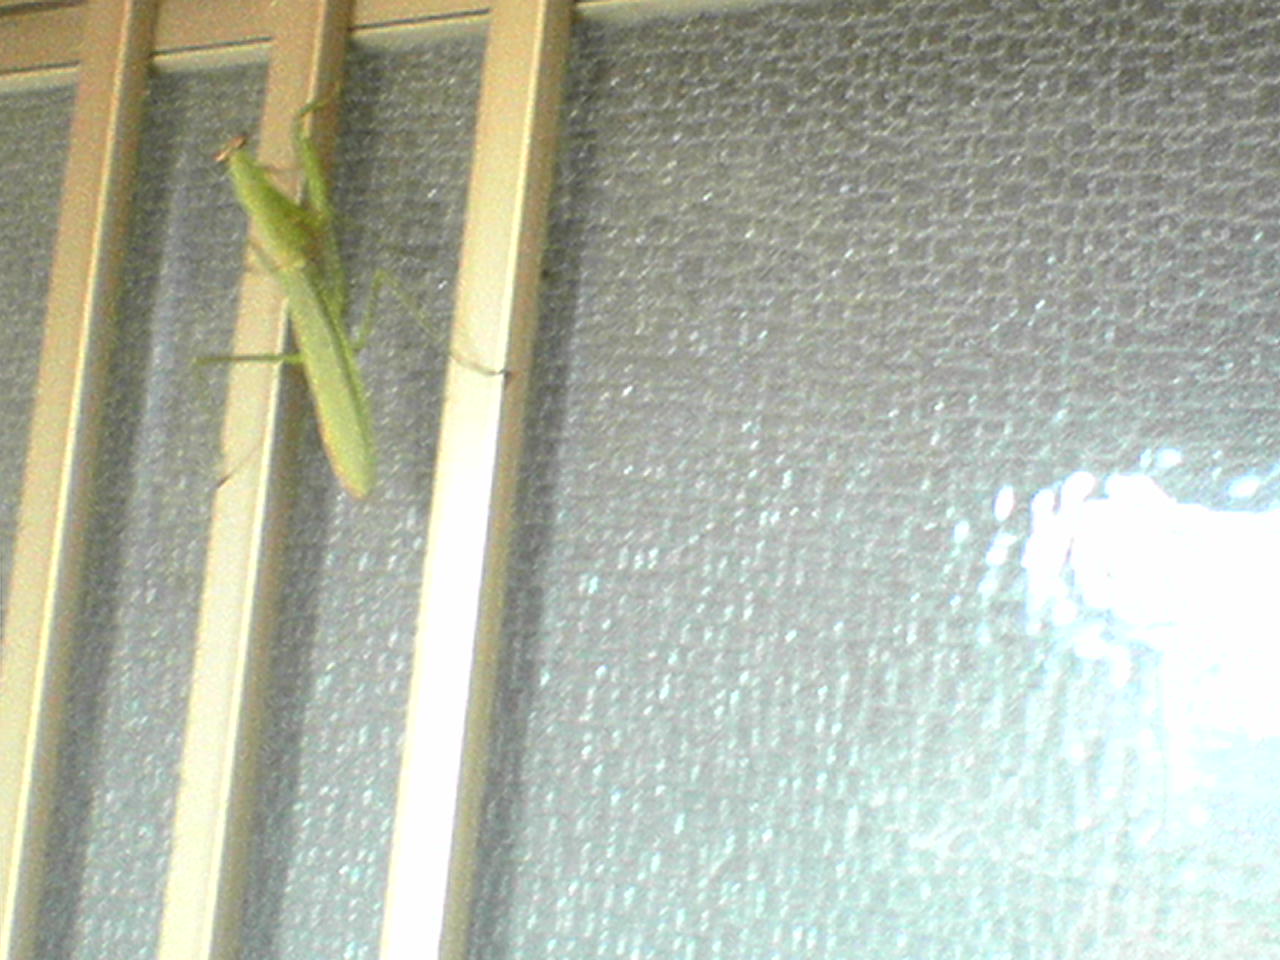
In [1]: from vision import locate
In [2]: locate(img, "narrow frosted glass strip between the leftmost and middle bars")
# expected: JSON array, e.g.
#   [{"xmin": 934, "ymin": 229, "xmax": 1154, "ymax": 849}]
[{"xmin": 37, "ymin": 69, "xmax": 261, "ymax": 960}]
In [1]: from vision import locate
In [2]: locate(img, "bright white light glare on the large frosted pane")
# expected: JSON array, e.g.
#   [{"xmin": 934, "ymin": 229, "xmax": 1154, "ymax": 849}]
[{"xmin": 979, "ymin": 451, "xmax": 1280, "ymax": 788}]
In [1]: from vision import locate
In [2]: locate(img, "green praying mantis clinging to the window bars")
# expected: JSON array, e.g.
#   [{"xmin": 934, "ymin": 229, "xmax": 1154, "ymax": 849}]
[{"xmin": 204, "ymin": 104, "xmax": 378, "ymax": 499}]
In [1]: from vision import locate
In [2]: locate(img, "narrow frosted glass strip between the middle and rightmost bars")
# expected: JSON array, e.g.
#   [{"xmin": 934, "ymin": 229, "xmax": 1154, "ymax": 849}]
[{"xmin": 244, "ymin": 32, "xmax": 484, "ymax": 960}]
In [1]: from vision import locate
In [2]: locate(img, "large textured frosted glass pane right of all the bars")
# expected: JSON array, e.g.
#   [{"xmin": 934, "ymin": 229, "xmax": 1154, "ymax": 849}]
[{"xmin": 471, "ymin": 0, "xmax": 1280, "ymax": 960}]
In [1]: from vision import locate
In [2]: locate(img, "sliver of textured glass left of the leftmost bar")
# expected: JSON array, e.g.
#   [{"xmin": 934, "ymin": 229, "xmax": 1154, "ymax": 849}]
[{"xmin": 0, "ymin": 82, "xmax": 72, "ymax": 623}]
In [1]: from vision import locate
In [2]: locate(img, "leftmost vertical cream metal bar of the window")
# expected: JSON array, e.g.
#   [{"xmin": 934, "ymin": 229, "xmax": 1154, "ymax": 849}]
[{"xmin": 0, "ymin": 0, "xmax": 156, "ymax": 960}]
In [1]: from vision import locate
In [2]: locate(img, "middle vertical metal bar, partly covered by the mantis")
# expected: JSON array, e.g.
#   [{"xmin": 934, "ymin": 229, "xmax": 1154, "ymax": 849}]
[{"xmin": 156, "ymin": 0, "xmax": 351, "ymax": 960}]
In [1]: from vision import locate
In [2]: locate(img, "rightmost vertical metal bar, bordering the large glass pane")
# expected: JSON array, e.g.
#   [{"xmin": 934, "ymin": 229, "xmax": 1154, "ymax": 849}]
[{"xmin": 380, "ymin": 0, "xmax": 572, "ymax": 960}]
